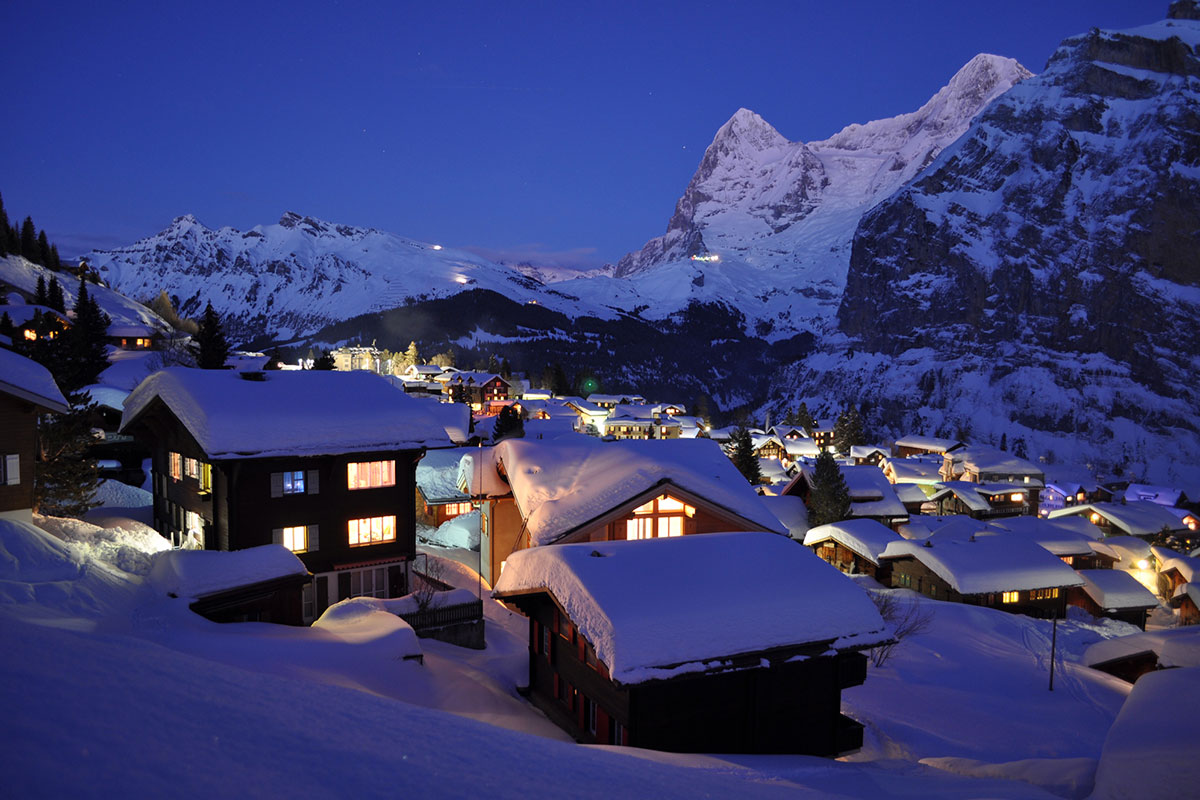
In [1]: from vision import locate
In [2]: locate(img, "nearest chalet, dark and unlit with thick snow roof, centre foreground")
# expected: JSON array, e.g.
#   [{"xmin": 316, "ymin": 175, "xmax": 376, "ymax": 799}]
[{"xmin": 493, "ymin": 533, "xmax": 889, "ymax": 757}]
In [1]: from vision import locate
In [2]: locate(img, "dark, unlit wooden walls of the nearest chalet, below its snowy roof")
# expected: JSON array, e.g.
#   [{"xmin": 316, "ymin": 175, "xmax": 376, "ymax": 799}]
[{"xmin": 506, "ymin": 591, "xmax": 866, "ymax": 757}]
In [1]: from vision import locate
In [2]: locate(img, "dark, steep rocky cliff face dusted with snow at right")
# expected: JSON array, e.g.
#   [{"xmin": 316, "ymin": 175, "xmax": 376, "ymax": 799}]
[{"xmin": 778, "ymin": 10, "xmax": 1200, "ymax": 489}]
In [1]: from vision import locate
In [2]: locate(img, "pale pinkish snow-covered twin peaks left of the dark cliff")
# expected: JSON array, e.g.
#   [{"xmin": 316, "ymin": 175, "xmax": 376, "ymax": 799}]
[{"xmin": 559, "ymin": 55, "xmax": 1031, "ymax": 338}]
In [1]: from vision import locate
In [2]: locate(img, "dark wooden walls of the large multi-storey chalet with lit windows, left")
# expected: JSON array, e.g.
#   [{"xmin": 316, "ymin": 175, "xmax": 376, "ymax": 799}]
[{"xmin": 128, "ymin": 399, "xmax": 424, "ymax": 620}]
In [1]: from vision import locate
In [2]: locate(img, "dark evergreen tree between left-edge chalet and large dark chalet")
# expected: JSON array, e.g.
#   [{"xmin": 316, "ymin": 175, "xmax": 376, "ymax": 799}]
[{"xmin": 34, "ymin": 395, "xmax": 100, "ymax": 517}]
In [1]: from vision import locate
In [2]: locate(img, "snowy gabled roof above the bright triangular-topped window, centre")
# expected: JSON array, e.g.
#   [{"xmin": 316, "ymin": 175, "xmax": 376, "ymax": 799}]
[{"xmin": 494, "ymin": 437, "xmax": 787, "ymax": 545}]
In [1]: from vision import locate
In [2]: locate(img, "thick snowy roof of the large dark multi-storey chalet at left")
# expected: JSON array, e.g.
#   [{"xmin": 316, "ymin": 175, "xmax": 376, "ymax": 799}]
[{"xmin": 121, "ymin": 367, "xmax": 450, "ymax": 459}]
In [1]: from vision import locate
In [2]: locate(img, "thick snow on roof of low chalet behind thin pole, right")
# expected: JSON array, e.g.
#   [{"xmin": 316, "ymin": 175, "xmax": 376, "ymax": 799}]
[{"xmin": 880, "ymin": 536, "xmax": 1084, "ymax": 595}]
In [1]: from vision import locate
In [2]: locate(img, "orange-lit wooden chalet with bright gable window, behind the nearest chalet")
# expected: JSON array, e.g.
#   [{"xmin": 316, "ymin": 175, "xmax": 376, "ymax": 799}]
[{"xmin": 458, "ymin": 437, "xmax": 787, "ymax": 585}]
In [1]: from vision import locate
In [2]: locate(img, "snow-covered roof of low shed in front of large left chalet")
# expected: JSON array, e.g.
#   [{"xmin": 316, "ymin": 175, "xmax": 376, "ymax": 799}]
[{"xmin": 146, "ymin": 545, "xmax": 308, "ymax": 597}]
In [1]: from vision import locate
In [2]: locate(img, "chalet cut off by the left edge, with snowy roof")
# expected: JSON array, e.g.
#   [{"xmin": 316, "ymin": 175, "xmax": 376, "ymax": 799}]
[{"xmin": 0, "ymin": 348, "xmax": 70, "ymax": 522}]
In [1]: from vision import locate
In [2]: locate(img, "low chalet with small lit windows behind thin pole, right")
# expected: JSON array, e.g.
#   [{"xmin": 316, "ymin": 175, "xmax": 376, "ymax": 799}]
[{"xmin": 880, "ymin": 535, "xmax": 1084, "ymax": 618}]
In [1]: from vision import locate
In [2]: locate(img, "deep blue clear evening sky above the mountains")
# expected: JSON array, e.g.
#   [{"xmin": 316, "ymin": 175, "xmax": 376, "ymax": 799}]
[{"xmin": 0, "ymin": 0, "xmax": 1168, "ymax": 264}]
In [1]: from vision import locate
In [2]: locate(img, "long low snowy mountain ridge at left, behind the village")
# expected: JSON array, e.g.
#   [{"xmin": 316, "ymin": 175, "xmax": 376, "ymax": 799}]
[{"xmin": 86, "ymin": 212, "xmax": 616, "ymax": 338}]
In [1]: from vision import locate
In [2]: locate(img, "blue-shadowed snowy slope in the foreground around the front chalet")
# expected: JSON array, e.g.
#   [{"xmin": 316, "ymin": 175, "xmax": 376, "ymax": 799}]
[{"xmin": 0, "ymin": 503, "xmax": 1194, "ymax": 798}]
